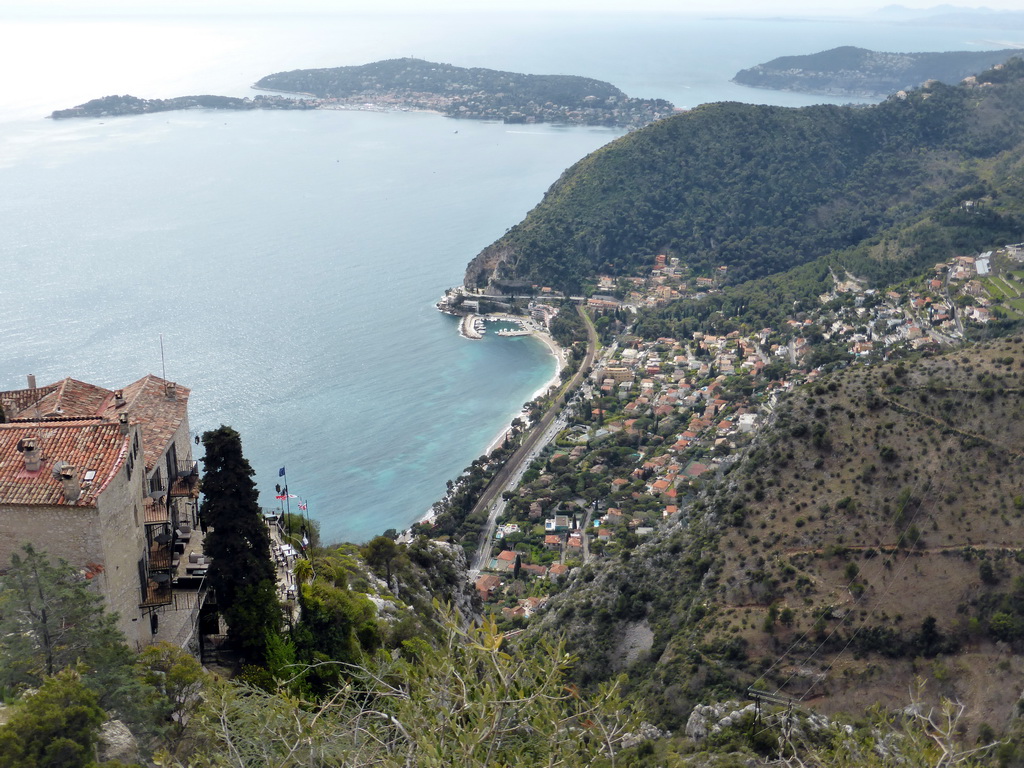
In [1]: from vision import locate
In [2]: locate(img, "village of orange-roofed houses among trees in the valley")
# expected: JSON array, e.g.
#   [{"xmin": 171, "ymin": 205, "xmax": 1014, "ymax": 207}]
[{"xmin": 468, "ymin": 240, "xmax": 1024, "ymax": 626}]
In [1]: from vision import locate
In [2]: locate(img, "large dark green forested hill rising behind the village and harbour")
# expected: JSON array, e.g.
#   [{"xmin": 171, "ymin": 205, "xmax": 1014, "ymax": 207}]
[{"xmin": 466, "ymin": 59, "xmax": 1024, "ymax": 292}]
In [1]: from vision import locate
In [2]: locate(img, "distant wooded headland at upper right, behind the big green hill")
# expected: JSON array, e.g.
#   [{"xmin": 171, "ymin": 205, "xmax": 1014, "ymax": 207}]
[{"xmin": 732, "ymin": 45, "xmax": 1021, "ymax": 97}]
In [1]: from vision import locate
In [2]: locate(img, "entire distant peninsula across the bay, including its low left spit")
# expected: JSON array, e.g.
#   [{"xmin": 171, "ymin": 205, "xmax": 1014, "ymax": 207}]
[{"xmin": 50, "ymin": 58, "xmax": 675, "ymax": 129}]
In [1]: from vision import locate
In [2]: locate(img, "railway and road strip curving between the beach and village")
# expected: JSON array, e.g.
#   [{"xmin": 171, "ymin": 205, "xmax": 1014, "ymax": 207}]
[{"xmin": 469, "ymin": 305, "xmax": 597, "ymax": 582}]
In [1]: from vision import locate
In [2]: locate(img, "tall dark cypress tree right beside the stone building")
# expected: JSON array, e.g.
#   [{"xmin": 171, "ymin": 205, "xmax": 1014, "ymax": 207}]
[{"xmin": 200, "ymin": 425, "xmax": 281, "ymax": 664}]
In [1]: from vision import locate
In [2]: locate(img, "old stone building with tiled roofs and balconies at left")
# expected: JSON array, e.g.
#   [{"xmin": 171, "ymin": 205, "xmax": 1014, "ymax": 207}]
[{"xmin": 0, "ymin": 375, "xmax": 206, "ymax": 648}]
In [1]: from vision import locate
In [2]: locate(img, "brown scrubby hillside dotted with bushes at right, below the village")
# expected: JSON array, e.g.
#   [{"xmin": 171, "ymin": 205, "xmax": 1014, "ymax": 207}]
[{"xmin": 527, "ymin": 336, "xmax": 1024, "ymax": 765}]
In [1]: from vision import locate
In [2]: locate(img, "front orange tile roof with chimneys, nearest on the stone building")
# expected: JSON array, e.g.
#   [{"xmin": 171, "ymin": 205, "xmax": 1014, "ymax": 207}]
[{"xmin": 0, "ymin": 420, "xmax": 129, "ymax": 507}]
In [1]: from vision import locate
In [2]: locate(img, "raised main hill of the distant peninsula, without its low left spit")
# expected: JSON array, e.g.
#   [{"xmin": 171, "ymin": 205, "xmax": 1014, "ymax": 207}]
[{"xmin": 255, "ymin": 58, "xmax": 674, "ymax": 128}]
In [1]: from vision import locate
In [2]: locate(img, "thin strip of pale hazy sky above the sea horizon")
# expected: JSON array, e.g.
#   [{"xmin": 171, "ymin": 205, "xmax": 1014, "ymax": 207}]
[{"xmin": 12, "ymin": 0, "xmax": 1024, "ymax": 16}]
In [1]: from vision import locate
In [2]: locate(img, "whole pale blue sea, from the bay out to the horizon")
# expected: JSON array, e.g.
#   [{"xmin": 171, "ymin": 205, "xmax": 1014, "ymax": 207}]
[{"xmin": 0, "ymin": 10, "xmax": 1024, "ymax": 542}]
